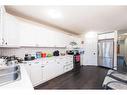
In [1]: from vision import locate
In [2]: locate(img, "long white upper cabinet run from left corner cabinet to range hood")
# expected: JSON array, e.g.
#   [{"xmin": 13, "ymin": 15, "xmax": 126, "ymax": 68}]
[{"xmin": 19, "ymin": 18, "xmax": 80, "ymax": 47}]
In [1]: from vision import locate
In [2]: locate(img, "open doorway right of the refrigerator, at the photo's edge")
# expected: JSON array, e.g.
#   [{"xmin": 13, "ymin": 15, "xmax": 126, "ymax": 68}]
[{"xmin": 117, "ymin": 32, "xmax": 127, "ymax": 72}]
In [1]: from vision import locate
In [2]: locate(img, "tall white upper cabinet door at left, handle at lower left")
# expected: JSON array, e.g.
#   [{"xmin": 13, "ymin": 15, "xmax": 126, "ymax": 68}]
[{"xmin": 3, "ymin": 14, "xmax": 19, "ymax": 47}]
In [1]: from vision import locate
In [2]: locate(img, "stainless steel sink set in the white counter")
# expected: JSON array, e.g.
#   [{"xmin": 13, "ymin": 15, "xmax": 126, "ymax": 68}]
[{"xmin": 0, "ymin": 65, "xmax": 21, "ymax": 85}]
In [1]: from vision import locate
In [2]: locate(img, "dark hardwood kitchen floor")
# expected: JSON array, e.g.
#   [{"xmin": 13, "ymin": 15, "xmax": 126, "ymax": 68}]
[{"xmin": 34, "ymin": 66, "xmax": 108, "ymax": 90}]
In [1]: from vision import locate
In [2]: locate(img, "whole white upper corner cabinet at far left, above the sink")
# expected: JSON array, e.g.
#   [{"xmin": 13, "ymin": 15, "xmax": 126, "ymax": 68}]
[{"xmin": 0, "ymin": 6, "xmax": 19, "ymax": 47}]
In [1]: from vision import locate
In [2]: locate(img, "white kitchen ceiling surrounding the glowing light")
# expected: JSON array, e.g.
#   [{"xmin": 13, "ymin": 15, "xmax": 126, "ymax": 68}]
[{"xmin": 6, "ymin": 6, "xmax": 127, "ymax": 34}]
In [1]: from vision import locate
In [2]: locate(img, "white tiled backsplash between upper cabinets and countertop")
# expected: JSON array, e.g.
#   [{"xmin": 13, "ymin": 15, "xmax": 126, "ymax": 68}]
[{"xmin": 0, "ymin": 47, "xmax": 66, "ymax": 58}]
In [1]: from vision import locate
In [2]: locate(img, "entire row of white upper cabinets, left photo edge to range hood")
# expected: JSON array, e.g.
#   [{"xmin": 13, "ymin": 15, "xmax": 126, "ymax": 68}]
[{"xmin": 0, "ymin": 7, "xmax": 79, "ymax": 47}]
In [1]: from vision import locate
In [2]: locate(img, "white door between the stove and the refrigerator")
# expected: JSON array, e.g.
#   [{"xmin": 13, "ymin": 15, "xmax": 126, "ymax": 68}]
[{"xmin": 83, "ymin": 37, "xmax": 97, "ymax": 65}]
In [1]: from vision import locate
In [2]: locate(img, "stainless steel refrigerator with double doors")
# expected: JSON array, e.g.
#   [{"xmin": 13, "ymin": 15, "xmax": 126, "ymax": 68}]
[{"xmin": 98, "ymin": 39, "xmax": 114, "ymax": 68}]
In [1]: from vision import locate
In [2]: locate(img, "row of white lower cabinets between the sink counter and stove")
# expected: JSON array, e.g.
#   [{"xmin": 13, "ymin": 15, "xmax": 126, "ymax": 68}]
[{"xmin": 25, "ymin": 56, "xmax": 73, "ymax": 86}]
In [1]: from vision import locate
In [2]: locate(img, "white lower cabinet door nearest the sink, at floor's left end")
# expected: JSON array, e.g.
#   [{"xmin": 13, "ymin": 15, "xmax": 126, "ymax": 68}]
[{"xmin": 30, "ymin": 63, "xmax": 42, "ymax": 86}]
